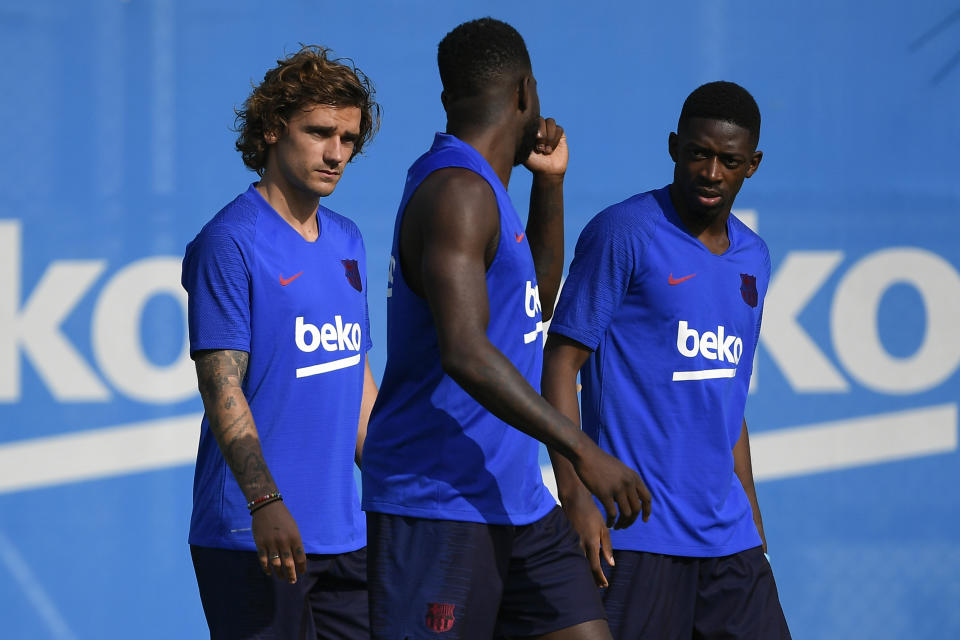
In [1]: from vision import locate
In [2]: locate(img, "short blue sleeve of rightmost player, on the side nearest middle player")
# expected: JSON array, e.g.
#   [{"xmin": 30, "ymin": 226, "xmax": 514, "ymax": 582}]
[{"xmin": 550, "ymin": 210, "xmax": 637, "ymax": 350}]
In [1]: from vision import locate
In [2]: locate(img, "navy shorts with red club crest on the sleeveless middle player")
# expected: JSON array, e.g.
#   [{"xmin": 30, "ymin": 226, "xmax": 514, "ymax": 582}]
[{"xmin": 367, "ymin": 507, "xmax": 605, "ymax": 640}]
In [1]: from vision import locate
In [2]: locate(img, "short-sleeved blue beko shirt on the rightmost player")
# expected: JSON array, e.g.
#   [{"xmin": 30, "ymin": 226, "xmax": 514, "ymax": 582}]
[{"xmin": 550, "ymin": 187, "xmax": 770, "ymax": 557}]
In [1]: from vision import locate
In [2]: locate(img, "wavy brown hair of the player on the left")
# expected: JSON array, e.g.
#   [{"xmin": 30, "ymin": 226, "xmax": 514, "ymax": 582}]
[{"xmin": 235, "ymin": 45, "xmax": 380, "ymax": 176}]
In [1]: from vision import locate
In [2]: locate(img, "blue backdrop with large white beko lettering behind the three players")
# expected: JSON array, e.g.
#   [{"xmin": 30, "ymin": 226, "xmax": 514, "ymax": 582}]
[{"xmin": 0, "ymin": 0, "xmax": 960, "ymax": 639}]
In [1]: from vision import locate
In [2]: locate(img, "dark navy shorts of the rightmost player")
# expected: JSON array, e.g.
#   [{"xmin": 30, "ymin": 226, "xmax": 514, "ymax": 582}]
[{"xmin": 601, "ymin": 547, "xmax": 790, "ymax": 640}]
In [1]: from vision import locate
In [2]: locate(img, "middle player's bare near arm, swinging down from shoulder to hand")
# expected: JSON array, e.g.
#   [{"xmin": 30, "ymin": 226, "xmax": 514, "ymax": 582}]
[{"xmin": 400, "ymin": 169, "xmax": 640, "ymax": 527}]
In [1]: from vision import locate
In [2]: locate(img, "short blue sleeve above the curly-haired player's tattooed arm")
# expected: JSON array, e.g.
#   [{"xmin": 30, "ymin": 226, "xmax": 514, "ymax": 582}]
[{"xmin": 181, "ymin": 229, "xmax": 250, "ymax": 355}]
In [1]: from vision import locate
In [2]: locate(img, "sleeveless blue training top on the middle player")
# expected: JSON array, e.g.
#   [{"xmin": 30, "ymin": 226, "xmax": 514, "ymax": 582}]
[{"xmin": 363, "ymin": 133, "xmax": 556, "ymax": 524}]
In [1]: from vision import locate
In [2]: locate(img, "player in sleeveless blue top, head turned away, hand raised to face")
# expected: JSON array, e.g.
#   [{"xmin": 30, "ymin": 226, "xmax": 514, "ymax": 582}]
[{"xmin": 363, "ymin": 18, "xmax": 649, "ymax": 640}]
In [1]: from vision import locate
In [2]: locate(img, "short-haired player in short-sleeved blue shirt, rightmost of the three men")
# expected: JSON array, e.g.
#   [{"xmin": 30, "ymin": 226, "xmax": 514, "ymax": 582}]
[{"xmin": 543, "ymin": 82, "xmax": 789, "ymax": 640}]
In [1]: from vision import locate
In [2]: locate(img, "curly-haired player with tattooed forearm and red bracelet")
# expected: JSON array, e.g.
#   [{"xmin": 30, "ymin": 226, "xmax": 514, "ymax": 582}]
[{"xmin": 182, "ymin": 47, "xmax": 380, "ymax": 640}]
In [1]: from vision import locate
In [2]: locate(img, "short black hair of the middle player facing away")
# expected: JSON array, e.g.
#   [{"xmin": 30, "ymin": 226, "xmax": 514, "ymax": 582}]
[{"xmin": 437, "ymin": 18, "xmax": 530, "ymax": 100}]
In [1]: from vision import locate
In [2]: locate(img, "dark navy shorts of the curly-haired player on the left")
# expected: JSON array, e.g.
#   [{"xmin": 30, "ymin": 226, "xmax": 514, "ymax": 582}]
[{"xmin": 190, "ymin": 545, "xmax": 370, "ymax": 640}]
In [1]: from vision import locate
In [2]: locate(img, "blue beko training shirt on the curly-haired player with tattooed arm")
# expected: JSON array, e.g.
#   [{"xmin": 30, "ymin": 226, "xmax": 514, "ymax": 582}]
[{"xmin": 182, "ymin": 185, "xmax": 370, "ymax": 553}]
